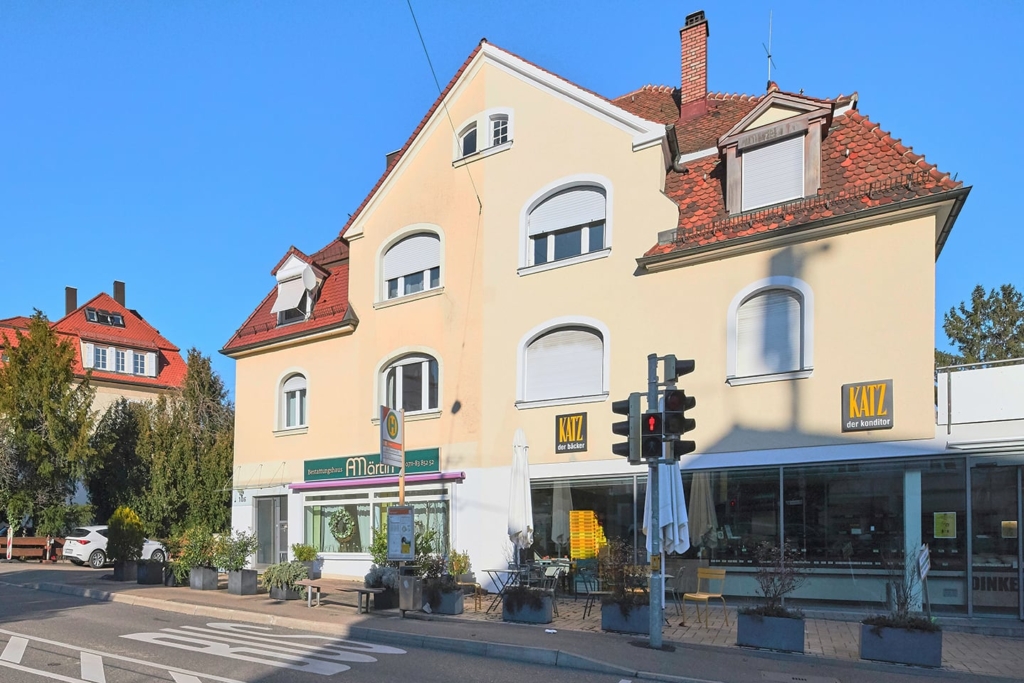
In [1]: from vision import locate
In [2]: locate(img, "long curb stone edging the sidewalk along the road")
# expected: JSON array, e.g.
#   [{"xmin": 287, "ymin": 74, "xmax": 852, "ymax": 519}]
[{"xmin": 0, "ymin": 581, "xmax": 717, "ymax": 683}]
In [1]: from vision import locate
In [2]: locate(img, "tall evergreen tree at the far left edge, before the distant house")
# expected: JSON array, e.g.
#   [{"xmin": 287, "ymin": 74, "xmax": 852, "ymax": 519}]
[{"xmin": 0, "ymin": 310, "xmax": 94, "ymax": 514}]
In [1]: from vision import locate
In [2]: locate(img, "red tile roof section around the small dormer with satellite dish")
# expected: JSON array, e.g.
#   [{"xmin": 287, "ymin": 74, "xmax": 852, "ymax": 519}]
[{"xmin": 221, "ymin": 239, "xmax": 352, "ymax": 353}]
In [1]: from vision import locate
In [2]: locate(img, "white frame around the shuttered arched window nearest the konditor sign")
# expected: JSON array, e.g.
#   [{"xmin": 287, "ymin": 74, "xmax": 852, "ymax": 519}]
[{"xmin": 725, "ymin": 275, "xmax": 814, "ymax": 386}]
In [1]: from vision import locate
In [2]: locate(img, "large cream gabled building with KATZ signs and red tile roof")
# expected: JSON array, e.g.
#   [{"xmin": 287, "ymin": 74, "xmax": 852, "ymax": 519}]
[{"xmin": 222, "ymin": 6, "xmax": 983, "ymax": 605}]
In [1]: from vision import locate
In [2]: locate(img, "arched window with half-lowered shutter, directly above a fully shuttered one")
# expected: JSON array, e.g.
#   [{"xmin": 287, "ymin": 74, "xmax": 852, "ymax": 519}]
[{"xmin": 526, "ymin": 184, "xmax": 608, "ymax": 266}]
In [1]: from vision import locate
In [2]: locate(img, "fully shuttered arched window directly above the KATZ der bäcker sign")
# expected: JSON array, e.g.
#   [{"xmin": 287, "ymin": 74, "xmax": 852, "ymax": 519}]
[{"xmin": 522, "ymin": 326, "xmax": 605, "ymax": 401}]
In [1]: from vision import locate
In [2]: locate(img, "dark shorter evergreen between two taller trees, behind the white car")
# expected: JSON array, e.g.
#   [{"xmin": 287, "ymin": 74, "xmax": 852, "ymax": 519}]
[{"xmin": 85, "ymin": 398, "xmax": 150, "ymax": 519}]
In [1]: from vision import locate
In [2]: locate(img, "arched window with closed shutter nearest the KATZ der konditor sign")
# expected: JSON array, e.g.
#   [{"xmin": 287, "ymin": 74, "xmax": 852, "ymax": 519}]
[{"xmin": 728, "ymin": 278, "xmax": 813, "ymax": 383}]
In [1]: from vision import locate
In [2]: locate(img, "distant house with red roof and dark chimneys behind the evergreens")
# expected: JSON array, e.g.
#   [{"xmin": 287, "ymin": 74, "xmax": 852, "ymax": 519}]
[{"xmin": 0, "ymin": 282, "xmax": 186, "ymax": 418}]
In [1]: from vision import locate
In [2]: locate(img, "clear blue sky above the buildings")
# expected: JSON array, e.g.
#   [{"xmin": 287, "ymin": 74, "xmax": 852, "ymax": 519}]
[{"xmin": 0, "ymin": 0, "xmax": 1024, "ymax": 387}]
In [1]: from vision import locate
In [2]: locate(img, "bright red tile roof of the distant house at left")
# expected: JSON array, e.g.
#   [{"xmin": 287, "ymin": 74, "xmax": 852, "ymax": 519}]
[{"xmin": 0, "ymin": 294, "xmax": 187, "ymax": 388}]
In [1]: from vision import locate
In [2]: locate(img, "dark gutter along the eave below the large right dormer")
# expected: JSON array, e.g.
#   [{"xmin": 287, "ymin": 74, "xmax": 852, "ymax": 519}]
[{"xmin": 637, "ymin": 187, "xmax": 971, "ymax": 272}]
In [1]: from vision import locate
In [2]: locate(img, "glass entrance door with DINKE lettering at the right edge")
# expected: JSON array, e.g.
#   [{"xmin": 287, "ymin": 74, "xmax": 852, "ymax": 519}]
[{"xmin": 971, "ymin": 466, "xmax": 1024, "ymax": 618}]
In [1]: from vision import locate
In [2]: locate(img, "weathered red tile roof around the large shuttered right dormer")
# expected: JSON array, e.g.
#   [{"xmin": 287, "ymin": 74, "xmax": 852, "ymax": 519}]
[{"xmin": 612, "ymin": 85, "xmax": 964, "ymax": 257}]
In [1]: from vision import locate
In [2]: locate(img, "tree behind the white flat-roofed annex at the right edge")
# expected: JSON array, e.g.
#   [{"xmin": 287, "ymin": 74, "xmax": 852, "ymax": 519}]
[{"xmin": 935, "ymin": 285, "xmax": 1024, "ymax": 366}]
